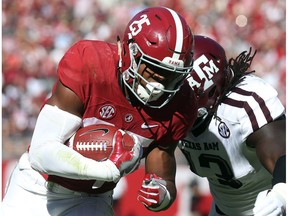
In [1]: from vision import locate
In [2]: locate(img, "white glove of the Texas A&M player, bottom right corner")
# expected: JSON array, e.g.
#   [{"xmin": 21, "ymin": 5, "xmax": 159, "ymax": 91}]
[{"xmin": 253, "ymin": 183, "xmax": 288, "ymax": 216}]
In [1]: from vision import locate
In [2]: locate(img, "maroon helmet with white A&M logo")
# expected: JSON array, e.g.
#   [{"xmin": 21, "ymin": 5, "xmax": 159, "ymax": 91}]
[{"xmin": 187, "ymin": 35, "xmax": 233, "ymax": 116}]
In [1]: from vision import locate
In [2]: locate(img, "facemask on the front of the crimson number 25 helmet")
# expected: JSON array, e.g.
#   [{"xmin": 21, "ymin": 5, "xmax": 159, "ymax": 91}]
[{"xmin": 123, "ymin": 41, "xmax": 192, "ymax": 108}]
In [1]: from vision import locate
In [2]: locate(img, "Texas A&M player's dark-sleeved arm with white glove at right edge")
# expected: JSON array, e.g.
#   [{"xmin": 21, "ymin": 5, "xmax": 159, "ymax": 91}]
[{"xmin": 247, "ymin": 116, "xmax": 288, "ymax": 216}]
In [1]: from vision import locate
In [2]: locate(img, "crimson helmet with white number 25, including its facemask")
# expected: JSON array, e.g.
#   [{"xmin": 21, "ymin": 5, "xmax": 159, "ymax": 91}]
[{"xmin": 121, "ymin": 7, "xmax": 194, "ymax": 108}]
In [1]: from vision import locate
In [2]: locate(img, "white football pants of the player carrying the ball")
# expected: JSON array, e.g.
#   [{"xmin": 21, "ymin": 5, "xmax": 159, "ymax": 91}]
[{"xmin": 0, "ymin": 153, "xmax": 114, "ymax": 216}]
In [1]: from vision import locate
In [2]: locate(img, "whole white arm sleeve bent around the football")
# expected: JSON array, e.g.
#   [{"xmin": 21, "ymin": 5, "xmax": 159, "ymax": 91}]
[{"xmin": 29, "ymin": 105, "xmax": 120, "ymax": 181}]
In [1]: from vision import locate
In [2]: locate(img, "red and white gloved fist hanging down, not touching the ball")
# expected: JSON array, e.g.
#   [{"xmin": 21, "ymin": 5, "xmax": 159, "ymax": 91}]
[{"xmin": 137, "ymin": 174, "xmax": 171, "ymax": 212}]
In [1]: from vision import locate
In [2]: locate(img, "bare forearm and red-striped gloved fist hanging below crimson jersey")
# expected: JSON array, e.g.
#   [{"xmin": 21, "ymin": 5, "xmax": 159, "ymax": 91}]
[{"xmin": 138, "ymin": 148, "xmax": 176, "ymax": 212}]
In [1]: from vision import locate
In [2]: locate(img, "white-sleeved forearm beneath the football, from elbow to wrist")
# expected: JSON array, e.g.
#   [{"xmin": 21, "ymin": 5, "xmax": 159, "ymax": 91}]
[{"xmin": 30, "ymin": 142, "xmax": 120, "ymax": 181}]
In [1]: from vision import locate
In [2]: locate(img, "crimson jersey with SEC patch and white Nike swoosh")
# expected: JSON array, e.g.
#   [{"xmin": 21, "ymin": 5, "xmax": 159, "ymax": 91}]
[{"xmin": 49, "ymin": 40, "xmax": 197, "ymax": 192}]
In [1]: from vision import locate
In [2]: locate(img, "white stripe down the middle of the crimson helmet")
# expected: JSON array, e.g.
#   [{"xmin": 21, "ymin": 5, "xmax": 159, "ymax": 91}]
[{"xmin": 167, "ymin": 8, "xmax": 183, "ymax": 60}]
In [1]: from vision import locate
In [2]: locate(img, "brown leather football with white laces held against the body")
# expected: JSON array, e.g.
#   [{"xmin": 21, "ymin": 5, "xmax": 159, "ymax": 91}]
[{"xmin": 68, "ymin": 124, "xmax": 134, "ymax": 161}]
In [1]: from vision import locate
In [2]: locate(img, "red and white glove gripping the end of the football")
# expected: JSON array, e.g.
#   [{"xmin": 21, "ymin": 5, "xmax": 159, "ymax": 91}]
[{"xmin": 109, "ymin": 130, "xmax": 143, "ymax": 176}]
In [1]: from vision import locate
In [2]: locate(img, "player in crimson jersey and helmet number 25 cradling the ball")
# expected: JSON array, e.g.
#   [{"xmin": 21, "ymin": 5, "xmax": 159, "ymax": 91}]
[{"xmin": 1, "ymin": 7, "xmax": 197, "ymax": 216}]
